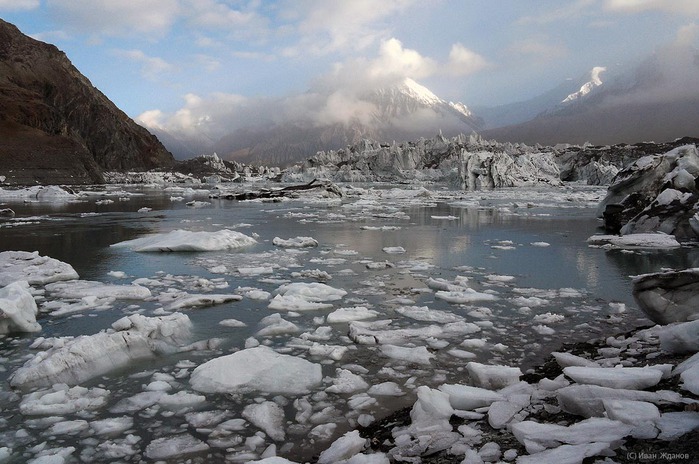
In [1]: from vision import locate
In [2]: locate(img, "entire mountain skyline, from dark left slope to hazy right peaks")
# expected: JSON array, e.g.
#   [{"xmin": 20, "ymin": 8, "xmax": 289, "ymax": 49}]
[{"xmin": 0, "ymin": 14, "xmax": 699, "ymax": 178}]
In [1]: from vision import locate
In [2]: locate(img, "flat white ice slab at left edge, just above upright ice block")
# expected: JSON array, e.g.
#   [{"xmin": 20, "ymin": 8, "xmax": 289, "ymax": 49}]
[{"xmin": 0, "ymin": 251, "xmax": 78, "ymax": 287}]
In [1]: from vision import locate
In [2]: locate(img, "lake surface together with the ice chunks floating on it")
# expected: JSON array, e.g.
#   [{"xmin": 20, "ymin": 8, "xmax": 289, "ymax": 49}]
[{"xmin": 0, "ymin": 186, "xmax": 696, "ymax": 462}]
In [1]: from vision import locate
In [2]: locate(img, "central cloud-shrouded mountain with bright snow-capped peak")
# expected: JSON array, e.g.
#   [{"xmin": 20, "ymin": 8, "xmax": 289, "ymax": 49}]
[{"xmin": 149, "ymin": 79, "xmax": 483, "ymax": 166}]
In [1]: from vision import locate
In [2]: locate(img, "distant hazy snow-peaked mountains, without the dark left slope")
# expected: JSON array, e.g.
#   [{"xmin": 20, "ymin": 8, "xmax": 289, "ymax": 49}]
[{"xmin": 151, "ymin": 40, "xmax": 699, "ymax": 166}]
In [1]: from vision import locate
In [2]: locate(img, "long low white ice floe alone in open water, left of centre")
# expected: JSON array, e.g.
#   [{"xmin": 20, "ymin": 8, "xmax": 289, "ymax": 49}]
[{"xmin": 112, "ymin": 229, "xmax": 257, "ymax": 252}]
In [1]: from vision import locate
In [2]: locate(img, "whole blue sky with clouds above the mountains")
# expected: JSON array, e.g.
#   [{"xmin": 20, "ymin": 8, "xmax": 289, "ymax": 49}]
[{"xmin": 0, "ymin": 0, "xmax": 699, "ymax": 134}]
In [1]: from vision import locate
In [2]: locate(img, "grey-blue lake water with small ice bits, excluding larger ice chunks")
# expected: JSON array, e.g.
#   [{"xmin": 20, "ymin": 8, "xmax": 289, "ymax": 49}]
[{"xmin": 0, "ymin": 184, "xmax": 699, "ymax": 462}]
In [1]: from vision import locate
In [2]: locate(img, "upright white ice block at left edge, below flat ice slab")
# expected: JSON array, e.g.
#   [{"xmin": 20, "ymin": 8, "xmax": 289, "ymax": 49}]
[{"xmin": 0, "ymin": 281, "xmax": 41, "ymax": 334}]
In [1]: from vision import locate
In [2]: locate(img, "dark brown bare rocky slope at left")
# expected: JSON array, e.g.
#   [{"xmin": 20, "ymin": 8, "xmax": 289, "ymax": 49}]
[{"xmin": 0, "ymin": 19, "xmax": 174, "ymax": 184}]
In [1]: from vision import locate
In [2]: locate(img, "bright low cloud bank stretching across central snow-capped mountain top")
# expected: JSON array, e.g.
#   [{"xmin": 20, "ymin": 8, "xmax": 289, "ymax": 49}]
[{"xmin": 139, "ymin": 38, "xmax": 488, "ymax": 139}]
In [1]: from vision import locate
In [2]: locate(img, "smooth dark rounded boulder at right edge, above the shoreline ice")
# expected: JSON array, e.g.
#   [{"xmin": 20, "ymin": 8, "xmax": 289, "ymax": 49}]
[{"xmin": 633, "ymin": 268, "xmax": 699, "ymax": 324}]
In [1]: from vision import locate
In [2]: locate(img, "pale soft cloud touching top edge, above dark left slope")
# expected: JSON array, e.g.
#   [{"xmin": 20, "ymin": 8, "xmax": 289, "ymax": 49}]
[{"xmin": 46, "ymin": 0, "xmax": 180, "ymax": 37}]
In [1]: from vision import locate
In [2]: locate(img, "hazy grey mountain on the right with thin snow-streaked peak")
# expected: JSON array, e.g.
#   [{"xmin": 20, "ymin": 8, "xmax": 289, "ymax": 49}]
[{"xmin": 479, "ymin": 45, "xmax": 699, "ymax": 145}]
